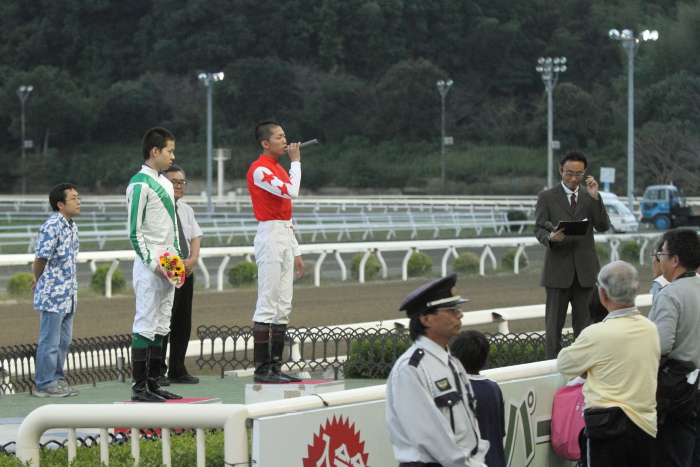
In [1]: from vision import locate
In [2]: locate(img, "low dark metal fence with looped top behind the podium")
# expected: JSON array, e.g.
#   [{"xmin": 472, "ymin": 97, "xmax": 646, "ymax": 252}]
[{"xmin": 0, "ymin": 326, "xmax": 566, "ymax": 394}]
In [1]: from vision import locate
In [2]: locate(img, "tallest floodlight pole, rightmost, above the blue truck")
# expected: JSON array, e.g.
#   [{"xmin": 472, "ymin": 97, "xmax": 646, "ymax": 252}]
[{"xmin": 608, "ymin": 29, "xmax": 659, "ymax": 212}]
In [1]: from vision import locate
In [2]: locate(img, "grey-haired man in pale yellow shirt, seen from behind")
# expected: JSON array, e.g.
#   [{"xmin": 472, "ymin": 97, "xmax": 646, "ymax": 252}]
[{"xmin": 557, "ymin": 261, "xmax": 660, "ymax": 467}]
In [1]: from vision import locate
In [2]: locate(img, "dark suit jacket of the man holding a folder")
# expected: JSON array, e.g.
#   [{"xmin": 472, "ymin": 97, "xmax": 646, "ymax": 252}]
[{"xmin": 535, "ymin": 183, "xmax": 610, "ymax": 289}]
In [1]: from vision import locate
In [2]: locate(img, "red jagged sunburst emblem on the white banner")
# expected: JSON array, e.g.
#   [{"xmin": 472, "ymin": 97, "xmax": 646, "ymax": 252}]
[{"xmin": 304, "ymin": 416, "xmax": 369, "ymax": 467}]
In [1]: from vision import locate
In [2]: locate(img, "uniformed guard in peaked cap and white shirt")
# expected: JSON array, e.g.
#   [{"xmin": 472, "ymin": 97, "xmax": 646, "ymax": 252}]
[{"xmin": 386, "ymin": 274, "xmax": 489, "ymax": 467}]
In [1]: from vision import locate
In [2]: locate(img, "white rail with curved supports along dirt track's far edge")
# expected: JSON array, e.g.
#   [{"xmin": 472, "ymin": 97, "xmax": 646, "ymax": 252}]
[{"xmin": 0, "ymin": 233, "xmax": 659, "ymax": 297}]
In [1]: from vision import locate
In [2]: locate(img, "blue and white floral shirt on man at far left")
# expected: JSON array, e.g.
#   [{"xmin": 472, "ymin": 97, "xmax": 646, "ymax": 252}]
[{"xmin": 34, "ymin": 212, "xmax": 80, "ymax": 313}]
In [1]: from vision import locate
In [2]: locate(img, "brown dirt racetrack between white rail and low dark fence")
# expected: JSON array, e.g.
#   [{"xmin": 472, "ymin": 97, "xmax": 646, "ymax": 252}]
[{"xmin": 0, "ymin": 266, "xmax": 652, "ymax": 346}]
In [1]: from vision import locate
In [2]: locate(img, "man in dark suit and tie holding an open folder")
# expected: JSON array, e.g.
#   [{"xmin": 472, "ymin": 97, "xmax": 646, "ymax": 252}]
[{"xmin": 535, "ymin": 151, "xmax": 610, "ymax": 359}]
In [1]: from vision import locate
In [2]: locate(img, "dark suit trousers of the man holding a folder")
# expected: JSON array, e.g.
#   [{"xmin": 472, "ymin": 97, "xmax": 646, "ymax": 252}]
[{"xmin": 545, "ymin": 274, "xmax": 593, "ymax": 359}]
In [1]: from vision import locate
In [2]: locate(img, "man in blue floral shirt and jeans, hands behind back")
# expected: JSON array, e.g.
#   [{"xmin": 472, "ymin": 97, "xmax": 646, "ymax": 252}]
[{"xmin": 31, "ymin": 183, "xmax": 80, "ymax": 397}]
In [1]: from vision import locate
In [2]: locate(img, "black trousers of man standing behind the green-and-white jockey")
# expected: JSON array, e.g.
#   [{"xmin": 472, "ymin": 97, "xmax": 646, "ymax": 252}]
[{"xmin": 160, "ymin": 274, "xmax": 194, "ymax": 378}]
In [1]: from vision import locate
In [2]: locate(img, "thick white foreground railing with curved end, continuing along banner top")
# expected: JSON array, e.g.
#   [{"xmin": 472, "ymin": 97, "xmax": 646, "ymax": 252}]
[{"xmin": 17, "ymin": 360, "xmax": 557, "ymax": 467}]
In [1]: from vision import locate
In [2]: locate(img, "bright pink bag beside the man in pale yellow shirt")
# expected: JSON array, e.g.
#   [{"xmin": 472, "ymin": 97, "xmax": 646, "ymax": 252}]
[{"xmin": 550, "ymin": 385, "xmax": 584, "ymax": 461}]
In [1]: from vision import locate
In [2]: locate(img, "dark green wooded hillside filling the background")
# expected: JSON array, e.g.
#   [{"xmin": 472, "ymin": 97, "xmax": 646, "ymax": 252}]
[{"xmin": 0, "ymin": 0, "xmax": 700, "ymax": 195}]
